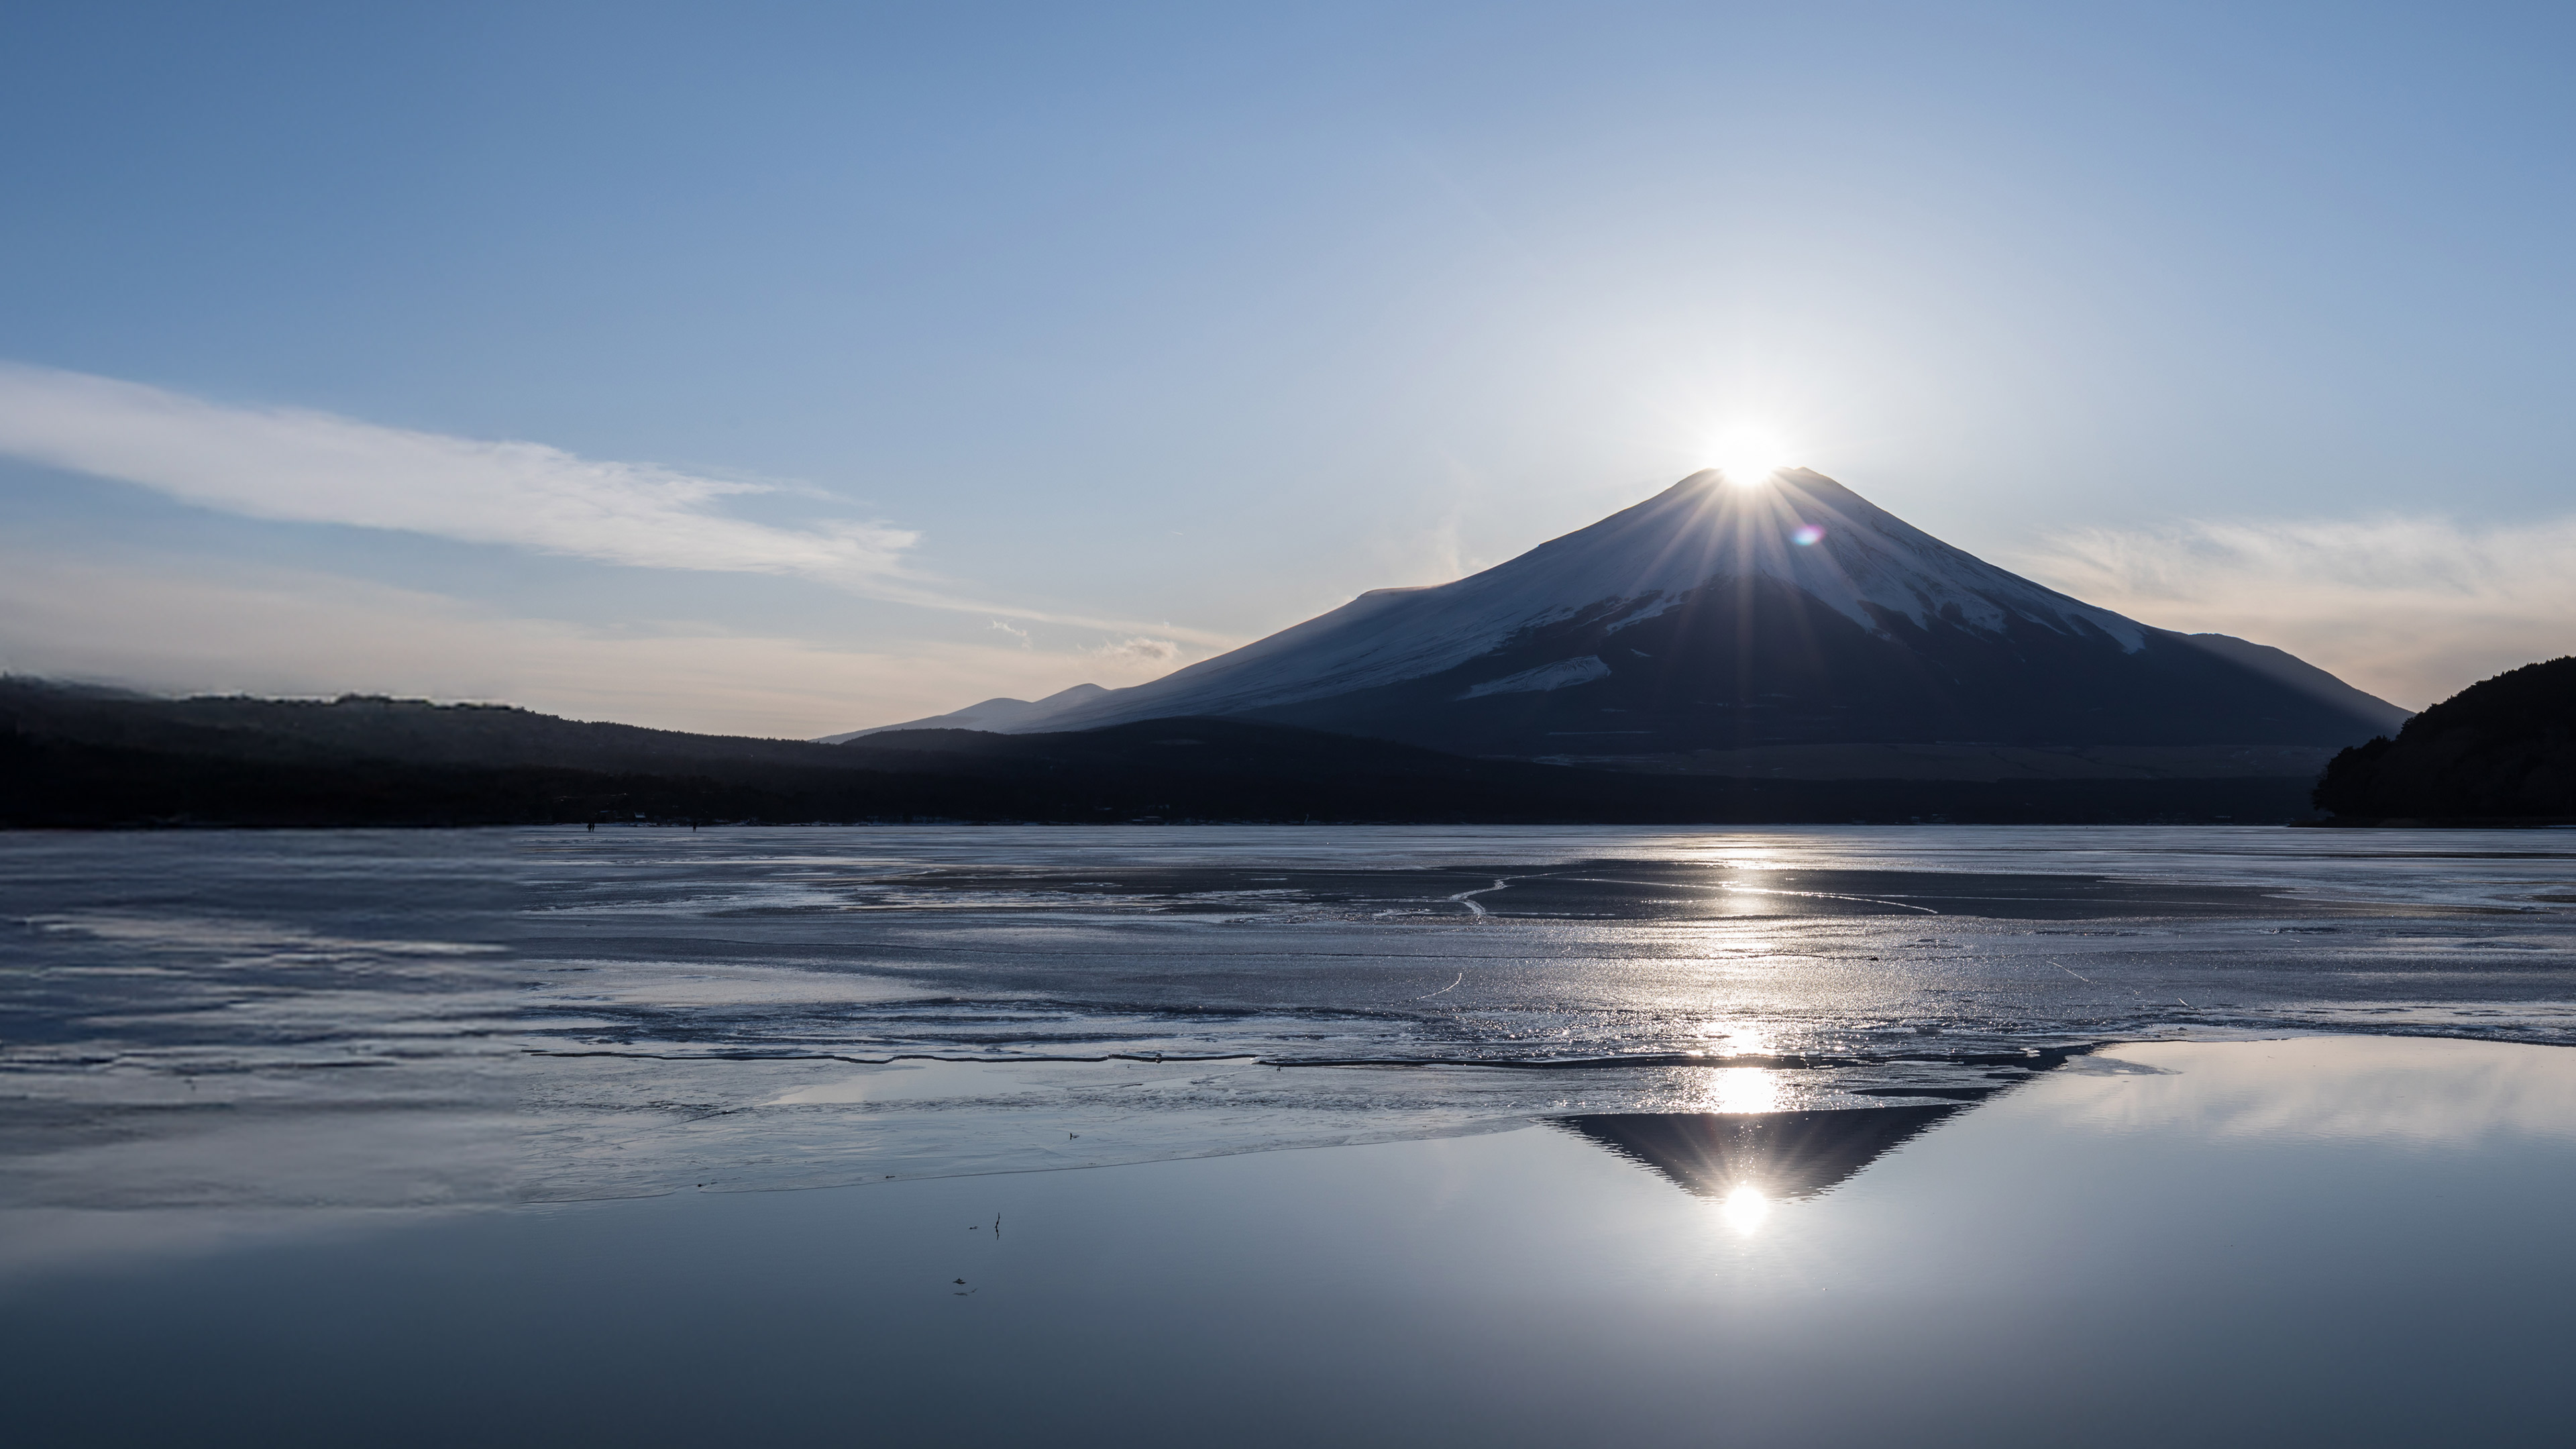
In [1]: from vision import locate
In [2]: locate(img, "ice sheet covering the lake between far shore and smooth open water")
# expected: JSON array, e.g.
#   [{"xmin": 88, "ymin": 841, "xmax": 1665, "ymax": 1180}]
[{"xmin": 0, "ymin": 828, "xmax": 2576, "ymax": 1206}]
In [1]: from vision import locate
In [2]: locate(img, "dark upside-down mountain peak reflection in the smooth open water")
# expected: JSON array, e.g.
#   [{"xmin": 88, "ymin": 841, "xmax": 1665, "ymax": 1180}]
[{"xmin": 1556, "ymin": 1106, "xmax": 1966, "ymax": 1201}]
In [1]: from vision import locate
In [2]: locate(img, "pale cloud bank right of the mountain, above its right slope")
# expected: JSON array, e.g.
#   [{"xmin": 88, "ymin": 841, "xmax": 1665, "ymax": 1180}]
[{"xmin": 2012, "ymin": 516, "xmax": 2576, "ymax": 706}]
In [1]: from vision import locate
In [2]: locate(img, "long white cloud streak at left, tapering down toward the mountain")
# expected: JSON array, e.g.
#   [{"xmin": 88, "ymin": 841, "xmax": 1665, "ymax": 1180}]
[{"xmin": 0, "ymin": 364, "xmax": 1246, "ymax": 642}]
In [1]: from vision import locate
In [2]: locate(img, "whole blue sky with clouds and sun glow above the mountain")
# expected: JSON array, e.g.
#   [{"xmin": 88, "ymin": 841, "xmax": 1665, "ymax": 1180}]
[{"xmin": 0, "ymin": 5, "xmax": 2576, "ymax": 735}]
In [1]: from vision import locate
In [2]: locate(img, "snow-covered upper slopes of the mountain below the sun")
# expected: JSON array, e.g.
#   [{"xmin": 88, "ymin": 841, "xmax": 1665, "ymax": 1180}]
[{"xmin": 1035, "ymin": 470, "xmax": 2146, "ymax": 730}]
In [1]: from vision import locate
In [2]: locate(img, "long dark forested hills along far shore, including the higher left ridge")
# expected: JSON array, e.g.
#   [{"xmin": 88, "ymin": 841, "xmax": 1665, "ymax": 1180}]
[{"xmin": 0, "ymin": 681, "xmax": 2306, "ymax": 828}]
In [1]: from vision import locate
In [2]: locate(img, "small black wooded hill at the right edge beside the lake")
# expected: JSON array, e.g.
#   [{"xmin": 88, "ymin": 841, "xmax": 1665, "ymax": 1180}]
[{"xmin": 2316, "ymin": 657, "xmax": 2576, "ymax": 820}]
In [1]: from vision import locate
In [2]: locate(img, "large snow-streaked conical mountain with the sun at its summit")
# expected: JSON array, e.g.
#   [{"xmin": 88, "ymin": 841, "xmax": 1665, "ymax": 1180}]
[{"xmin": 865, "ymin": 470, "xmax": 2406, "ymax": 773}]
